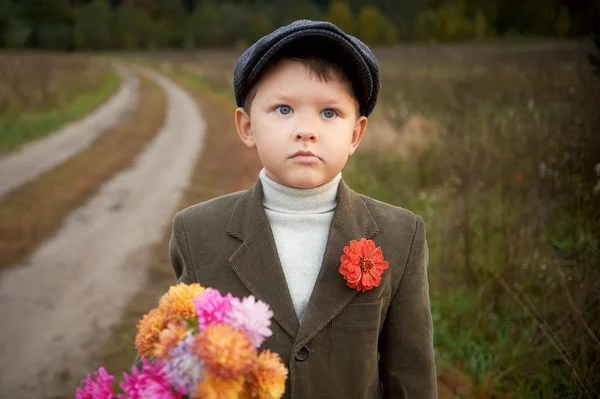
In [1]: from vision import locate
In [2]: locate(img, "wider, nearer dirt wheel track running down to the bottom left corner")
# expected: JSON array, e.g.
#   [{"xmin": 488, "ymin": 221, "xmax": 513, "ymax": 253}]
[{"xmin": 0, "ymin": 70, "xmax": 204, "ymax": 399}]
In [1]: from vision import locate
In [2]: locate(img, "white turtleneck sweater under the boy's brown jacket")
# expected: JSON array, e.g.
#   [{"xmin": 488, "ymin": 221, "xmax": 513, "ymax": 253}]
[{"xmin": 259, "ymin": 169, "xmax": 342, "ymax": 321}]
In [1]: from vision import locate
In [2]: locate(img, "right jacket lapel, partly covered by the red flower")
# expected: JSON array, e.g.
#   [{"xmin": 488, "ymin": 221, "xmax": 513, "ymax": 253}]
[{"xmin": 292, "ymin": 180, "xmax": 379, "ymax": 350}]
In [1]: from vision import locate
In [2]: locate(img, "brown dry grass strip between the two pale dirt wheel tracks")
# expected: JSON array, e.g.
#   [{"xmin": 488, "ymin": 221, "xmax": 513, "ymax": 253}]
[{"xmin": 0, "ymin": 74, "xmax": 166, "ymax": 268}]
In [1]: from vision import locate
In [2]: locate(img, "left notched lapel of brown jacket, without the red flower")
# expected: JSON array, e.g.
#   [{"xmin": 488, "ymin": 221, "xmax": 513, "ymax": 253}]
[{"xmin": 227, "ymin": 180, "xmax": 299, "ymax": 337}]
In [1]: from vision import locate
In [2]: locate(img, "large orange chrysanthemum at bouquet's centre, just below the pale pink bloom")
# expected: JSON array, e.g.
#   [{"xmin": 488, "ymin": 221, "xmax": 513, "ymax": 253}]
[{"xmin": 192, "ymin": 323, "xmax": 256, "ymax": 378}]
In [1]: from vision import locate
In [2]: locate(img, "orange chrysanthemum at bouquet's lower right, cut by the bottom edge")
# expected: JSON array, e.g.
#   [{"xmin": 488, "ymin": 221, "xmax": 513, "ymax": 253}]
[{"xmin": 243, "ymin": 349, "xmax": 288, "ymax": 399}]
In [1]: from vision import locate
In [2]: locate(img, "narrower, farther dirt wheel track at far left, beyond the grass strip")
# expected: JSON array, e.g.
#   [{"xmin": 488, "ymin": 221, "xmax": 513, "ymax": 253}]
[{"xmin": 0, "ymin": 65, "xmax": 139, "ymax": 198}]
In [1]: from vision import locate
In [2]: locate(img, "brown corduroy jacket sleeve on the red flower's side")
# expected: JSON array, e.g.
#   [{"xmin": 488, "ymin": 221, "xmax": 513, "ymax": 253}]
[{"xmin": 379, "ymin": 217, "xmax": 437, "ymax": 399}]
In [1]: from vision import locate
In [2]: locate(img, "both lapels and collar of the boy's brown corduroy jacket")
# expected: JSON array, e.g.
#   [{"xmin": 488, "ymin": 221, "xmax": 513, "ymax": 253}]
[{"xmin": 227, "ymin": 180, "xmax": 379, "ymax": 349}]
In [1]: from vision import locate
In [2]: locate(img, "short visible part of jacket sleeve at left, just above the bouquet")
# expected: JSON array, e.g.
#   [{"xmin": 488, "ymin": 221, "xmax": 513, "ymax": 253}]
[{"xmin": 169, "ymin": 211, "xmax": 197, "ymax": 284}]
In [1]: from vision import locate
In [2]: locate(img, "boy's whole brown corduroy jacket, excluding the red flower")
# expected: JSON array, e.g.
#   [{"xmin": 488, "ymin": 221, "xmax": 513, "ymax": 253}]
[{"xmin": 169, "ymin": 180, "xmax": 437, "ymax": 399}]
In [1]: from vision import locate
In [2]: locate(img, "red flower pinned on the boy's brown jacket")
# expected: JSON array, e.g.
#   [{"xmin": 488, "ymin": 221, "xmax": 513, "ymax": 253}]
[{"xmin": 340, "ymin": 238, "xmax": 389, "ymax": 292}]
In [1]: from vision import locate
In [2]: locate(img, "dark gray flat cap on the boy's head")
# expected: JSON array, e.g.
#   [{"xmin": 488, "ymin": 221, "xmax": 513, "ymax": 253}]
[{"xmin": 233, "ymin": 20, "xmax": 381, "ymax": 116}]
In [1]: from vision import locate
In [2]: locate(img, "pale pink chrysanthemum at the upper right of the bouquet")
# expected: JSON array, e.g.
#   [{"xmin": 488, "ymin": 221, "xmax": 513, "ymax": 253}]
[{"xmin": 225, "ymin": 295, "xmax": 273, "ymax": 348}]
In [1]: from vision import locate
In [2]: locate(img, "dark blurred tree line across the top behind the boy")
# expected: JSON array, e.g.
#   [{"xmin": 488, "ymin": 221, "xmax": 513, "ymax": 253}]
[{"xmin": 0, "ymin": 0, "xmax": 599, "ymax": 50}]
